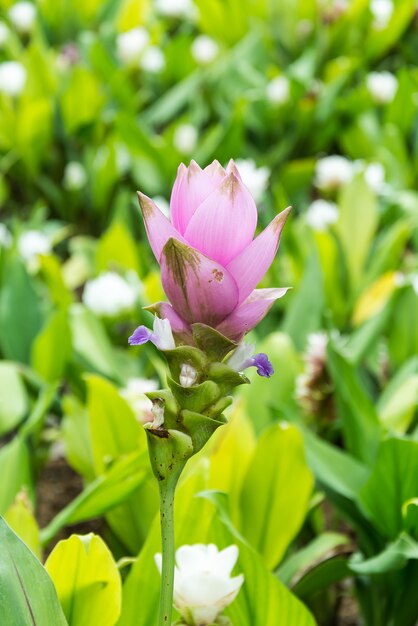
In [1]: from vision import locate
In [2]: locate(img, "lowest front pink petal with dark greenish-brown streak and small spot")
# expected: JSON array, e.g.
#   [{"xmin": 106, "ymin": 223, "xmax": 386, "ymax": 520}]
[{"xmin": 161, "ymin": 239, "xmax": 238, "ymax": 326}]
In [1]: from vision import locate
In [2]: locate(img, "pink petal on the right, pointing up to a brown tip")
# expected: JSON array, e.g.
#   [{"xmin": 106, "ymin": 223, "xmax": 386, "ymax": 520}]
[{"xmin": 227, "ymin": 207, "xmax": 291, "ymax": 304}]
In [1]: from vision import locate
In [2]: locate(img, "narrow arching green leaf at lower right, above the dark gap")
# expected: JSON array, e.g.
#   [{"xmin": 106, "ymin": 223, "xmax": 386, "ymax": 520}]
[{"xmin": 276, "ymin": 532, "xmax": 349, "ymax": 585}]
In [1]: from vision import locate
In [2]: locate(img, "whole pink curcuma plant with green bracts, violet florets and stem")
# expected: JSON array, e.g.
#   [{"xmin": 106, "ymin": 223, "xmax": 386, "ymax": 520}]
[{"xmin": 129, "ymin": 161, "xmax": 290, "ymax": 626}]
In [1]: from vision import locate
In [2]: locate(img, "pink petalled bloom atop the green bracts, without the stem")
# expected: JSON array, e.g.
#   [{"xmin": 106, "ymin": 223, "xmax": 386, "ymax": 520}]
[{"xmin": 138, "ymin": 160, "xmax": 290, "ymax": 341}]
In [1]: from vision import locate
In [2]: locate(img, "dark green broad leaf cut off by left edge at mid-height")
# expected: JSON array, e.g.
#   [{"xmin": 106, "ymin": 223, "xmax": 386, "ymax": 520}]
[{"xmin": 0, "ymin": 259, "xmax": 42, "ymax": 363}]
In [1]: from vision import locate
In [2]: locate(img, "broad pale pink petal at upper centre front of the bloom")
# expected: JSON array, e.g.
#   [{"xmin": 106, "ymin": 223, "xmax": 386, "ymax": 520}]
[{"xmin": 184, "ymin": 173, "xmax": 257, "ymax": 266}]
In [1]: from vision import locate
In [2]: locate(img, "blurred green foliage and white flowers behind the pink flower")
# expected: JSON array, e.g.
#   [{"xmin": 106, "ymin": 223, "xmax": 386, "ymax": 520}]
[{"xmin": 0, "ymin": 0, "xmax": 418, "ymax": 626}]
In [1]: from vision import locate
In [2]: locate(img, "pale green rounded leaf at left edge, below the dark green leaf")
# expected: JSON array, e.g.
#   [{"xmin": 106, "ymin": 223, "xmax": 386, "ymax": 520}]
[{"xmin": 0, "ymin": 361, "xmax": 28, "ymax": 436}]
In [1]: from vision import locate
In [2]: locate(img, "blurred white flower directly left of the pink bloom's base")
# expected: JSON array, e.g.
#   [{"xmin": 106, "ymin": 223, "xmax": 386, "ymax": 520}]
[{"xmin": 83, "ymin": 272, "xmax": 137, "ymax": 317}]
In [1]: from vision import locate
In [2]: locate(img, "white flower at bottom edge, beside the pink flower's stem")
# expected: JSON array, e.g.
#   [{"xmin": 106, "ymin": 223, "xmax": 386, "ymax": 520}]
[{"xmin": 155, "ymin": 544, "xmax": 244, "ymax": 626}]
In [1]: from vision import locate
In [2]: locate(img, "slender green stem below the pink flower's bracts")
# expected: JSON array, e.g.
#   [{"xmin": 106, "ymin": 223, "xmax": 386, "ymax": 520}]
[{"xmin": 158, "ymin": 476, "xmax": 177, "ymax": 626}]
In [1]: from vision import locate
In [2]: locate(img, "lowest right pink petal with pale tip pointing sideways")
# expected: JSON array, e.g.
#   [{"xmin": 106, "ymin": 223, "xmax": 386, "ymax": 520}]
[{"xmin": 217, "ymin": 287, "xmax": 288, "ymax": 341}]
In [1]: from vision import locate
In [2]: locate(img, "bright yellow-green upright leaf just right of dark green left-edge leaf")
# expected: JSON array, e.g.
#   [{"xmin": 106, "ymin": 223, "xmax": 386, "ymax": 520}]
[{"xmin": 31, "ymin": 311, "xmax": 71, "ymax": 382}]
